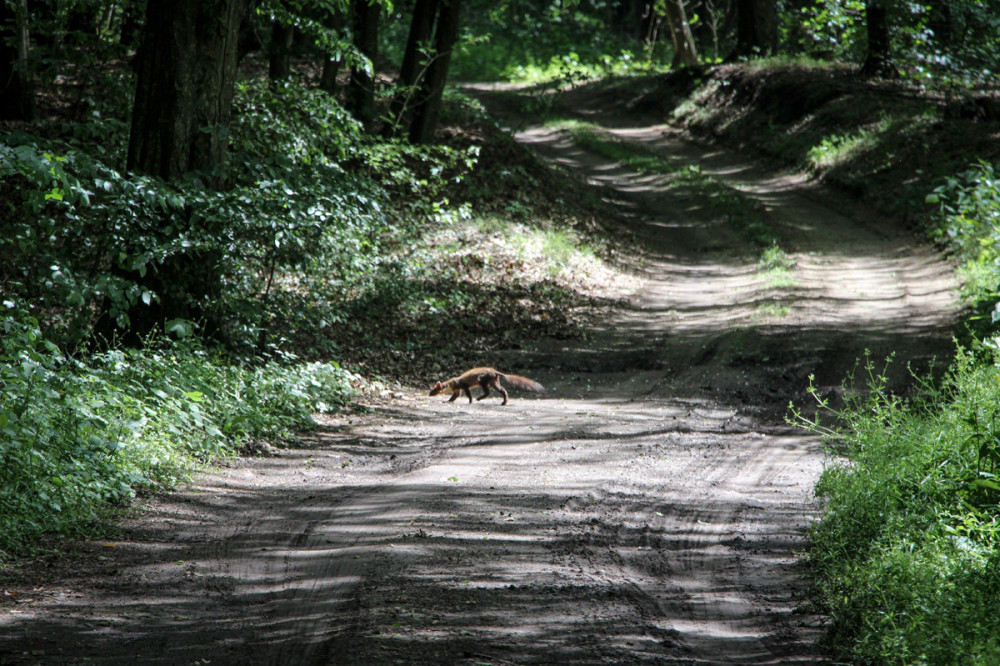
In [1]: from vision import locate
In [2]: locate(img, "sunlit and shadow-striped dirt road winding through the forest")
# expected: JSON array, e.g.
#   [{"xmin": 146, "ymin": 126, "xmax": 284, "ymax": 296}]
[{"xmin": 0, "ymin": 92, "xmax": 954, "ymax": 665}]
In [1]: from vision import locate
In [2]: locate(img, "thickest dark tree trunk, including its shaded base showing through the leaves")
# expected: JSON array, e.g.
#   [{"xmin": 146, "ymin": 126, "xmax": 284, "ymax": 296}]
[{"xmin": 117, "ymin": 0, "xmax": 249, "ymax": 342}]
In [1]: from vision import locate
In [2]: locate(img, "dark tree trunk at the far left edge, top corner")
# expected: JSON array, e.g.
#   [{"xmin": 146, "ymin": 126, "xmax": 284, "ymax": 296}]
[{"xmin": 0, "ymin": 0, "xmax": 35, "ymax": 120}]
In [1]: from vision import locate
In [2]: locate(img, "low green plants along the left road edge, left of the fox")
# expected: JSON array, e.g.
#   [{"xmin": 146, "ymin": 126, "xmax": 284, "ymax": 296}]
[{"xmin": 0, "ymin": 301, "xmax": 355, "ymax": 559}]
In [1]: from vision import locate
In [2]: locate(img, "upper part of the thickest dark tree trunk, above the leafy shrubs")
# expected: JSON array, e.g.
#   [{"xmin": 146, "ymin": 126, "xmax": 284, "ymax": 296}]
[{"xmin": 126, "ymin": 0, "xmax": 249, "ymax": 186}]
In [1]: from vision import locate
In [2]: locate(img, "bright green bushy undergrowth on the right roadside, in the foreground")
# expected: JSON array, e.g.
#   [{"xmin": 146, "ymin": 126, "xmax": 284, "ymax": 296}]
[{"xmin": 799, "ymin": 348, "xmax": 1000, "ymax": 665}]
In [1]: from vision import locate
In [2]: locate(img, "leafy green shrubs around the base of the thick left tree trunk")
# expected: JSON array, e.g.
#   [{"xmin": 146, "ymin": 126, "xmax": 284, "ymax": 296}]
[{"xmin": 0, "ymin": 76, "xmax": 475, "ymax": 352}]
